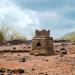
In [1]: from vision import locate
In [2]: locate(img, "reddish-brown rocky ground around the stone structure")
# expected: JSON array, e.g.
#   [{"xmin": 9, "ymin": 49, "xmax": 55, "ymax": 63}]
[{"xmin": 0, "ymin": 42, "xmax": 75, "ymax": 75}]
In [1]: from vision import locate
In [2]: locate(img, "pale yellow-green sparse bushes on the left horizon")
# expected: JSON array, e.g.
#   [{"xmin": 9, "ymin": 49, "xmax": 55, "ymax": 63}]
[{"xmin": 0, "ymin": 25, "xmax": 27, "ymax": 42}]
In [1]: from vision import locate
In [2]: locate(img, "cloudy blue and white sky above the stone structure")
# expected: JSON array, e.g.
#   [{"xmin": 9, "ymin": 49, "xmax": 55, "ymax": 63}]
[{"xmin": 0, "ymin": 0, "xmax": 75, "ymax": 38}]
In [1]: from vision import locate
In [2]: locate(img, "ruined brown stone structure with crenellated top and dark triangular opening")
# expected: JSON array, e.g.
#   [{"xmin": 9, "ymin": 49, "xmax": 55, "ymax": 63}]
[{"xmin": 31, "ymin": 30, "xmax": 54, "ymax": 55}]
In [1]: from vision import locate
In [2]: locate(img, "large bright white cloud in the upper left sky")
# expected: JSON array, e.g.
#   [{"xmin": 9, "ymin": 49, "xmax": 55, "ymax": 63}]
[{"xmin": 0, "ymin": 0, "xmax": 39, "ymax": 39}]
